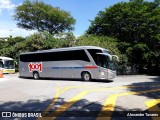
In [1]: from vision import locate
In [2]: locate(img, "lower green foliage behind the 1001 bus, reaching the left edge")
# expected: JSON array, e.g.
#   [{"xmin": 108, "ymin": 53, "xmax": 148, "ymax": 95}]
[{"xmin": 0, "ymin": 32, "xmax": 75, "ymax": 61}]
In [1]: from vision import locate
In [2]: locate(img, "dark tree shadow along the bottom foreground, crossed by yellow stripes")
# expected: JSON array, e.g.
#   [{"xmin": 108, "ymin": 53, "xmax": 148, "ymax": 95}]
[{"xmin": 0, "ymin": 98, "xmax": 155, "ymax": 120}]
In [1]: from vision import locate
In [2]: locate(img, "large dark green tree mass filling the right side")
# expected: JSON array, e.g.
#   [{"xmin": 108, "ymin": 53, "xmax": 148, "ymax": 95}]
[{"xmin": 86, "ymin": 0, "xmax": 160, "ymax": 74}]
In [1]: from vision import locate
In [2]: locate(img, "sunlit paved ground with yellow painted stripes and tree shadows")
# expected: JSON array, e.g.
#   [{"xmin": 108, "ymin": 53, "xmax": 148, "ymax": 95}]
[{"xmin": 0, "ymin": 74, "xmax": 160, "ymax": 120}]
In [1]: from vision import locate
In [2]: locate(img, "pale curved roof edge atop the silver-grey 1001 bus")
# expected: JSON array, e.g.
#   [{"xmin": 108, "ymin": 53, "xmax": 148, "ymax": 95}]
[{"xmin": 21, "ymin": 46, "xmax": 109, "ymax": 54}]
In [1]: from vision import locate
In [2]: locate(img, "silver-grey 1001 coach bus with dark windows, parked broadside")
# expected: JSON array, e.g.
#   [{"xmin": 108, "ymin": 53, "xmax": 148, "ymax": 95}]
[{"xmin": 19, "ymin": 46, "xmax": 118, "ymax": 81}]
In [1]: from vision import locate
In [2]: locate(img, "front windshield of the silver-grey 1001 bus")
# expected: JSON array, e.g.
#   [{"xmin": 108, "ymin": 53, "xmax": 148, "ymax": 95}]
[{"xmin": 97, "ymin": 54, "xmax": 116, "ymax": 70}]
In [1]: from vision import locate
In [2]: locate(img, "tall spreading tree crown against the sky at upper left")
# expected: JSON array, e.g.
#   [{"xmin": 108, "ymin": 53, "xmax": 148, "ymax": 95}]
[{"xmin": 13, "ymin": 0, "xmax": 75, "ymax": 34}]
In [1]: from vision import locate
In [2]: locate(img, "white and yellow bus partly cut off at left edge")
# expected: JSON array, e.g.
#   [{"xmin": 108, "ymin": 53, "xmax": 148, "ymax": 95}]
[{"xmin": 0, "ymin": 56, "xmax": 15, "ymax": 73}]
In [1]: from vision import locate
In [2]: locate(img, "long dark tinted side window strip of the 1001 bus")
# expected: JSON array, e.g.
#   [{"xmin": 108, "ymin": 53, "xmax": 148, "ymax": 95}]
[{"xmin": 20, "ymin": 50, "xmax": 89, "ymax": 62}]
